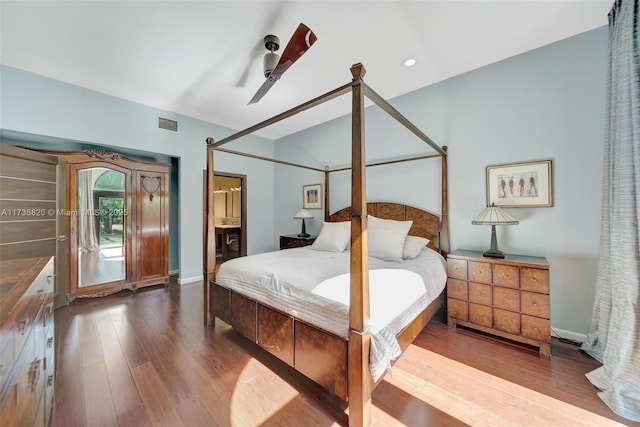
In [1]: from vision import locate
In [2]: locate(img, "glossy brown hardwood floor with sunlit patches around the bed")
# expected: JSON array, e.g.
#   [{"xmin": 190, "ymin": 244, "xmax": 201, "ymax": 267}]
[{"xmin": 53, "ymin": 283, "xmax": 631, "ymax": 427}]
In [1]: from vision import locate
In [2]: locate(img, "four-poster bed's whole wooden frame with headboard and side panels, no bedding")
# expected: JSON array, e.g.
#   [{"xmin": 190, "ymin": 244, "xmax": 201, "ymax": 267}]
[{"xmin": 204, "ymin": 64, "xmax": 449, "ymax": 425}]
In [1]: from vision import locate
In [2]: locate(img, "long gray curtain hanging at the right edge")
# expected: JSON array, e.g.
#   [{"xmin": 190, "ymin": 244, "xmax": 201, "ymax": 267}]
[{"xmin": 582, "ymin": 0, "xmax": 640, "ymax": 421}]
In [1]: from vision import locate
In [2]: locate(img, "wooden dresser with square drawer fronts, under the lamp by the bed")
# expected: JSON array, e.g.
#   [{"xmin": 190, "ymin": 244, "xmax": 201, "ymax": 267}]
[{"xmin": 447, "ymin": 250, "xmax": 551, "ymax": 357}]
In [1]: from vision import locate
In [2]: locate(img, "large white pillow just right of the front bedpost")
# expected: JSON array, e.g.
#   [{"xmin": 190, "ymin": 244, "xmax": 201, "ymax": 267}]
[{"xmin": 367, "ymin": 215, "xmax": 413, "ymax": 261}]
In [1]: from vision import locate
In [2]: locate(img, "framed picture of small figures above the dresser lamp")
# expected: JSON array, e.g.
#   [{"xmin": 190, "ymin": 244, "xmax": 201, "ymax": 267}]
[{"xmin": 487, "ymin": 160, "xmax": 553, "ymax": 208}]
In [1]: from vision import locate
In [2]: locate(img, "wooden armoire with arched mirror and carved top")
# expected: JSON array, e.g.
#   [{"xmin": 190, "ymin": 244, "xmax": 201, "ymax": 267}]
[{"xmin": 49, "ymin": 150, "xmax": 169, "ymax": 301}]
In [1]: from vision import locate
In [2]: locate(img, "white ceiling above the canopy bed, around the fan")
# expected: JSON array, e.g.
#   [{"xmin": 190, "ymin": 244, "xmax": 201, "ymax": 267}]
[{"xmin": 0, "ymin": 0, "xmax": 612, "ymax": 139}]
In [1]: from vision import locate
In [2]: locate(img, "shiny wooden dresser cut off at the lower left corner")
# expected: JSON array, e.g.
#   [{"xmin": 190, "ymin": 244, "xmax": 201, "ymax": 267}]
[{"xmin": 0, "ymin": 257, "xmax": 55, "ymax": 426}]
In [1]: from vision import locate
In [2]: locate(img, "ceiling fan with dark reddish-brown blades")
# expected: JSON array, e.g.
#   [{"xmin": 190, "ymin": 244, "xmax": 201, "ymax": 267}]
[{"xmin": 249, "ymin": 24, "xmax": 318, "ymax": 104}]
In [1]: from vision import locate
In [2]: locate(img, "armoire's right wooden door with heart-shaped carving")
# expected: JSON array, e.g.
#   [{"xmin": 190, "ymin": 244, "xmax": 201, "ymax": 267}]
[{"xmin": 134, "ymin": 170, "xmax": 169, "ymax": 286}]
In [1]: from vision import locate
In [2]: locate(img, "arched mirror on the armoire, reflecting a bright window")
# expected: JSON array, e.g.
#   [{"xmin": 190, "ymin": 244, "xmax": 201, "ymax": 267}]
[{"xmin": 76, "ymin": 167, "xmax": 128, "ymax": 288}]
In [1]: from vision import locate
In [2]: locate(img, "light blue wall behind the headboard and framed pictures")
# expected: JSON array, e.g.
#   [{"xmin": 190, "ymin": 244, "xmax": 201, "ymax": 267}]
[{"xmin": 275, "ymin": 27, "xmax": 607, "ymax": 334}]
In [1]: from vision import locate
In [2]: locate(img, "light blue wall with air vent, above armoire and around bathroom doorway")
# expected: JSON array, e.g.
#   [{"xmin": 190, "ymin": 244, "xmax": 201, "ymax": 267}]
[{"xmin": 0, "ymin": 65, "xmax": 274, "ymax": 282}]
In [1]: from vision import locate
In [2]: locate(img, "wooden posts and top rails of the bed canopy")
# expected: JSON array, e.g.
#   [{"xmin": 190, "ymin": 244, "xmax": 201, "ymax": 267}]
[{"xmin": 203, "ymin": 63, "xmax": 449, "ymax": 426}]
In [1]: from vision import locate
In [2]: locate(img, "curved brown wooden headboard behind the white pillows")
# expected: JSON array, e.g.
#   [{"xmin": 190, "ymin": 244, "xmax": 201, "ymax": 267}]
[{"xmin": 329, "ymin": 202, "xmax": 440, "ymax": 251}]
